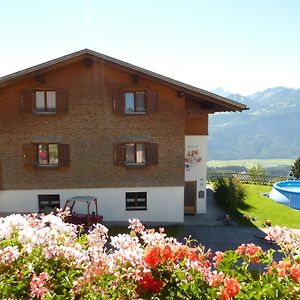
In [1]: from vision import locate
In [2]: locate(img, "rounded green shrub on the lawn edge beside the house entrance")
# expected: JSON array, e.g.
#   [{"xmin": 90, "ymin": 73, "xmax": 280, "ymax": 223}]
[{"xmin": 213, "ymin": 177, "xmax": 246, "ymax": 211}]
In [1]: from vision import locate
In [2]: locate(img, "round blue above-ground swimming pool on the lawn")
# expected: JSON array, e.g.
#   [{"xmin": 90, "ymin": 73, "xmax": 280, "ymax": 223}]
[{"xmin": 269, "ymin": 180, "xmax": 300, "ymax": 209}]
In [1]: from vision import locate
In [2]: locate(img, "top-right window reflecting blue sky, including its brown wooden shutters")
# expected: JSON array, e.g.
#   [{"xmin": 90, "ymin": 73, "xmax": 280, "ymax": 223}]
[{"xmin": 113, "ymin": 91, "xmax": 158, "ymax": 115}]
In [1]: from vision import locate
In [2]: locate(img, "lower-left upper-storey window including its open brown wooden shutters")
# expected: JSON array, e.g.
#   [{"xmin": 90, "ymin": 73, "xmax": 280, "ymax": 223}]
[{"xmin": 23, "ymin": 143, "xmax": 70, "ymax": 169}]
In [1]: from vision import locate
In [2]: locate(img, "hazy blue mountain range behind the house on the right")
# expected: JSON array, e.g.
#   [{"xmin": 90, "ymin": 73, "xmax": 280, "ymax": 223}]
[{"xmin": 208, "ymin": 87, "xmax": 300, "ymax": 160}]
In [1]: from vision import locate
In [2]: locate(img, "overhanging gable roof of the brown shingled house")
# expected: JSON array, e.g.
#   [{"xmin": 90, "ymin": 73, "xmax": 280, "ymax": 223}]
[{"xmin": 0, "ymin": 49, "xmax": 248, "ymax": 113}]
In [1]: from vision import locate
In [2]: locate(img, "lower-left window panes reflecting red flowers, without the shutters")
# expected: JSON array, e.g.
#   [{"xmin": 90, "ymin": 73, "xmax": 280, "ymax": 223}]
[{"xmin": 37, "ymin": 144, "xmax": 58, "ymax": 166}]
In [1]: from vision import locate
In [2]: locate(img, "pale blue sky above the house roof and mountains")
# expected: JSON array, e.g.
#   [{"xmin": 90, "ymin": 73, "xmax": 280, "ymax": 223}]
[{"xmin": 0, "ymin": 0, "xmax": 300, "ymax": 95}]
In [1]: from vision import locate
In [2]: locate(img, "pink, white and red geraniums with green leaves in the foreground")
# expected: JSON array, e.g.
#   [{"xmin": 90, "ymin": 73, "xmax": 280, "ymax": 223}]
[{"xmin": 0, "ymin": 213, "xmax": 300, "ymax": 299}]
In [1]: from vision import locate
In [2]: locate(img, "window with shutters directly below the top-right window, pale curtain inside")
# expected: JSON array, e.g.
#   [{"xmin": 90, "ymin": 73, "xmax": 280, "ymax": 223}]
[{"xmin": 113, "ymin": 142, "xmax": 158, "ymax": 167}]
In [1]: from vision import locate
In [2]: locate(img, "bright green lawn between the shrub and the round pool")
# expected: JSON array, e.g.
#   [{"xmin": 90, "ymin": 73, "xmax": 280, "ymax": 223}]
[{"xmin": 237, "ymin": 184, "xmax": 300, "ymax": 228}]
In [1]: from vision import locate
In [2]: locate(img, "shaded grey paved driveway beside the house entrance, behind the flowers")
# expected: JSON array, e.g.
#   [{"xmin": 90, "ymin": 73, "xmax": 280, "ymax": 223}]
[{"xmin": 179, "ymin": 186, "xmax": 276, "ymax": 252}]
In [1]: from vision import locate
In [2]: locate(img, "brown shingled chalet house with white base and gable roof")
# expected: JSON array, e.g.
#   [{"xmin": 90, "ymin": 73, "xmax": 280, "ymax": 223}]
[{"xmin": 0, "ymin": 49, "xmax": 246, "ymax": 223}]
